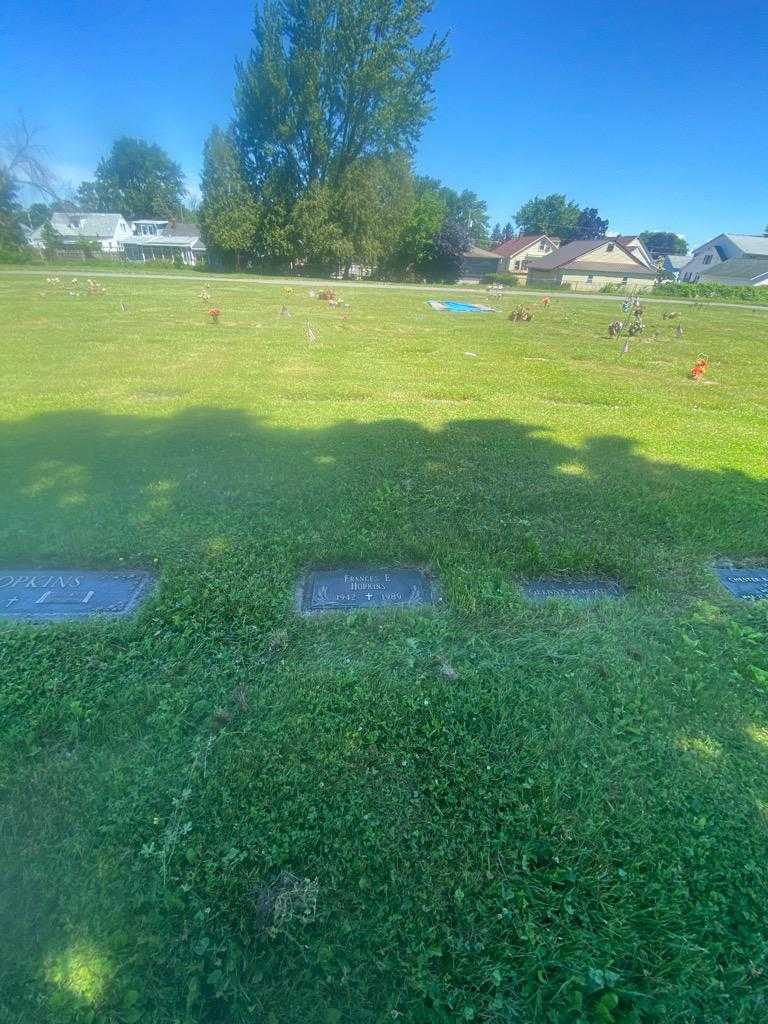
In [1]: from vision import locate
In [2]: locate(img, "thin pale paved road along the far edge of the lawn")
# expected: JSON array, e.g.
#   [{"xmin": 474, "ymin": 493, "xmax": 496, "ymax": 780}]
[{"xmin": 6, "ymin": 268, "xmax": 768, "ymax": 313}]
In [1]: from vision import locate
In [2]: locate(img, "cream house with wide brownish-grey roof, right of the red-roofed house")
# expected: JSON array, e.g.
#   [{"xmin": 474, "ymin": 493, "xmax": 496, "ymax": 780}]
[{"xmin": 528, "ymin": 239, "xmax": 656, "ymax": 292}]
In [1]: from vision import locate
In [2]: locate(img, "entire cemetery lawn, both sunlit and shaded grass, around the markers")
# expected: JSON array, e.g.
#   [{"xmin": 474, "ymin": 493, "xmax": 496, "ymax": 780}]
[{"xmin": 0, "ymin": 273, "xmax": 768, "ymax": 1024}]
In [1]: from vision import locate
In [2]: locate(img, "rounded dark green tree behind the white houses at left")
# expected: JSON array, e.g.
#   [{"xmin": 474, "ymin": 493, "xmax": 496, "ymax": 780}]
[{"xmin": 76, "ymin": 136, "xmax": 185, "ymax": 220}]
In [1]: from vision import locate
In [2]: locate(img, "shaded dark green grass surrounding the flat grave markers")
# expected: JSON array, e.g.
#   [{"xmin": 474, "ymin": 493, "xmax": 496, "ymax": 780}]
[{"xmin": 0, "ymin": 409, "xmax": 768, "ymax": 1022}]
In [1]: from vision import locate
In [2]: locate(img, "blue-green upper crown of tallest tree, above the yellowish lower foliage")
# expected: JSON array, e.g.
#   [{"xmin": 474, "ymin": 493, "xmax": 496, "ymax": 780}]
[{"xmin": 234, "ymin": 0, "xmax": 446, "ymax": 200}]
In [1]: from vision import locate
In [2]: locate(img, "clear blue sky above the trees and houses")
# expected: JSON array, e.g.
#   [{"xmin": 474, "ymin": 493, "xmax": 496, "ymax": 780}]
[{"xmin": 0, "ymin": 0, "xmax": 768, "ymax": 243}]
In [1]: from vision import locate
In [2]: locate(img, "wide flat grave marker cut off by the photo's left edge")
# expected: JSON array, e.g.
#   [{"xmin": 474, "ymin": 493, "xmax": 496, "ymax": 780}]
[{"xmin": 0, "ymin": 569, "xmax": 154, "ymax": 622}]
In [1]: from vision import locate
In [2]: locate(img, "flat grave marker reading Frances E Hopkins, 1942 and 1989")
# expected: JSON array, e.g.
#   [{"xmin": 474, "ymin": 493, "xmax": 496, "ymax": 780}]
[{"xmin": 296, "ymin": 568, "xmax": 439, "ymax": 615}]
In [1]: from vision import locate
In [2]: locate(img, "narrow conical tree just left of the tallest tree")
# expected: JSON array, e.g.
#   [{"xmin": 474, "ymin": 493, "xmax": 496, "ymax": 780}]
[{"xmin": 199, "ymin": 127, "xmax": 261, "ymax": 268}]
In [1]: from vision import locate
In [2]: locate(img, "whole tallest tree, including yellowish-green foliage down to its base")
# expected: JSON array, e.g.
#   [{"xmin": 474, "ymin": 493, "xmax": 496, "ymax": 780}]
[{"xmin": 227, "ymin": 0, "xmax": 450, "ymax": 273}]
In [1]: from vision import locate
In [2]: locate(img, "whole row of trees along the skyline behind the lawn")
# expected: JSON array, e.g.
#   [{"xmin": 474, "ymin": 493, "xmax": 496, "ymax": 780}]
[{"xmin": 0, "ymin": 0, "xmax": 700, "ymax": 278}]
